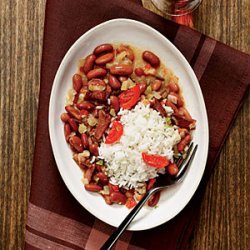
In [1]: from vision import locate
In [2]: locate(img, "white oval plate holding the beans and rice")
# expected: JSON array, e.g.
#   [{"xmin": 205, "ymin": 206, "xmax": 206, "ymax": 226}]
[{"xmin": 49, "ymin": 19, "xmax": 208, "ymax": 230}]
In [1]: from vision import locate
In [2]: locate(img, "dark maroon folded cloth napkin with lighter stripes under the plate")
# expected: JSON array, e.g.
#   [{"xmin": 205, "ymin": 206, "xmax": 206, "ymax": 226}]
[{"xmin": 26, "ymin": 0, "xmax": 250, "ymax": 250}]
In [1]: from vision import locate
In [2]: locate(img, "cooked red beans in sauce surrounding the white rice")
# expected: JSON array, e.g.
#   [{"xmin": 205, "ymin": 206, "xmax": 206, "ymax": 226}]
[{"xmin": 60, "ymin": 43, "xmax": 195, "ymax": 208}]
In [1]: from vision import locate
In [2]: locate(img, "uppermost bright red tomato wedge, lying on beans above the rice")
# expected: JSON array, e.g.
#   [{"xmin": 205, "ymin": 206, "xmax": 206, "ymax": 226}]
[{"xmin": 119, "ymin": 84, "xmax": 140, "ymax": 109}]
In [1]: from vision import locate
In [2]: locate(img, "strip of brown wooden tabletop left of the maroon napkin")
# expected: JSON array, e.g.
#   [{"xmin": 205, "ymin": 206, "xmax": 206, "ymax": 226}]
[{"xmin": 0, "ymin": 0, "xmax": 45, "ymax": 249}]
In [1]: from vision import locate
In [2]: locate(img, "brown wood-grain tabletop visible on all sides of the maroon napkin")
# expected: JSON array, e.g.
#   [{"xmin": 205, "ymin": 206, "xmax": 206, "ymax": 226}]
[{"xmin": 0, "ymin": 0, "xmax": 250, "ymax": 250}]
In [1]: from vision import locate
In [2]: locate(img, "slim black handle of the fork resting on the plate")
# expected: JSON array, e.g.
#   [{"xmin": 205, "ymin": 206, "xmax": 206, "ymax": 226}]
[{"xmin": 100, "ymin": 188, "xmax": 158, "ymax": 250}]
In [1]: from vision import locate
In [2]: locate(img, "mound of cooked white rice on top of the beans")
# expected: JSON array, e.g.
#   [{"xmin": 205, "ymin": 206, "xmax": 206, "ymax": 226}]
[{"xmin": 99, "ymin": 102, "xmax": 181, "ymax": 188}]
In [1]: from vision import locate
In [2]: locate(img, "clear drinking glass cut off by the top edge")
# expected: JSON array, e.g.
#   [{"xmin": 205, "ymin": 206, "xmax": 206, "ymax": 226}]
[{"xmin": 151, "ymin": 0, "xmax": 201, "ymax": 16}]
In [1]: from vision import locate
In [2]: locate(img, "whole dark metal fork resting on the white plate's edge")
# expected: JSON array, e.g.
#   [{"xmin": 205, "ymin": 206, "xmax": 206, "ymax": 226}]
[{"xmin": 100, "ymin": 143, "xmax": 198, "ymax": 250}]
